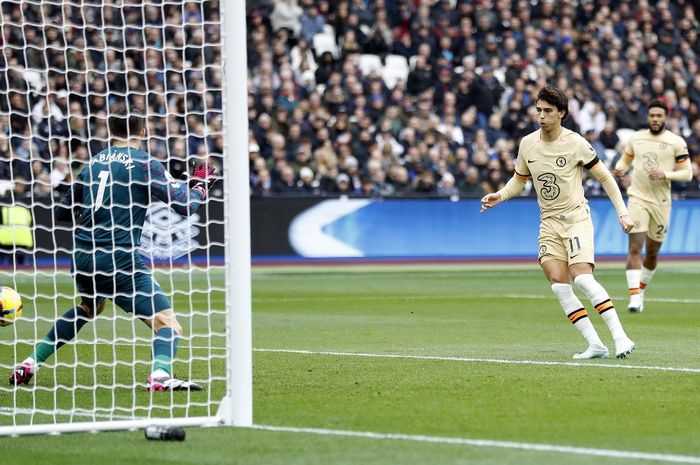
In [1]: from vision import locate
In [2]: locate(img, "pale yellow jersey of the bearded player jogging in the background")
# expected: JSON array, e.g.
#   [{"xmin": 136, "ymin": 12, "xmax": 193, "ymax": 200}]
[{"xmin": 623, "ymin": 129, "xmax": 688, "ymax": 204}]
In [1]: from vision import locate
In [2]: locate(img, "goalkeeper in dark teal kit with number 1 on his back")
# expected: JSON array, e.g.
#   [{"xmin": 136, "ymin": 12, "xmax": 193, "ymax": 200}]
[{"xmin": 10, "ymin": 106, "xmax": 214, "ymax": 391}]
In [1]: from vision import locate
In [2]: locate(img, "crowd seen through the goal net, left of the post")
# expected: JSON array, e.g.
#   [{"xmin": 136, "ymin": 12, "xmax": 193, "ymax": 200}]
[{"xmin": 0, "ymin": 0, "xmax": 223, "ymax": 198}]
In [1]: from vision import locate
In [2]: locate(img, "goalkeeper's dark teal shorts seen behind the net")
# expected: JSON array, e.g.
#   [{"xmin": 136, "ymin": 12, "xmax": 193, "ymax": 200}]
[{"xmin": 71, "ymin": 247, "xmax": 171, "ymax": 318}]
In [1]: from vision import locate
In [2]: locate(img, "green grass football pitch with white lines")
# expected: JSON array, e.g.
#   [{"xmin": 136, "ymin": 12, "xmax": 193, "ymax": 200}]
[{"xmin": 0, "ymin": 261, "xmax": 700, "ymax": 465}]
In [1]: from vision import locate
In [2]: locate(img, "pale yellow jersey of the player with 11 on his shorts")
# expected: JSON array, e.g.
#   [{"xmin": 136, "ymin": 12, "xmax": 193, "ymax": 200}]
[{"xmin": 515, "ymin": 128, "xmax": 599, "ymax": 219}]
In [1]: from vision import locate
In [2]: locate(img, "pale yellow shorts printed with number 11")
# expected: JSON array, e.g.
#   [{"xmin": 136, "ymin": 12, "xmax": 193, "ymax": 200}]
[{"xmin": 537, "ymin": 205, "xmax": 595, "ymax": 265}]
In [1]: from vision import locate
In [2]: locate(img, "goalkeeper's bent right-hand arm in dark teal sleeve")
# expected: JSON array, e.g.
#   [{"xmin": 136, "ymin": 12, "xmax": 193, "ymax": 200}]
[{"xmin": 149, "ymin": 160, "xmax": 207, "ymax": 216}]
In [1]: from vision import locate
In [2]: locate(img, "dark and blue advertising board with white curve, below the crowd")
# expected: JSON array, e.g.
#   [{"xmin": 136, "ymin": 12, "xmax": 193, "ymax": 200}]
[{"xmin": 12, "ymin": 198, "xmax": 700, "ymax": 266}]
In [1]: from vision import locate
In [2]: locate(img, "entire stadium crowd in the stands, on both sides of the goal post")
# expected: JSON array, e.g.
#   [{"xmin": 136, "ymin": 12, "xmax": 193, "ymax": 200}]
[{"xmin": 0, "ymin": 0, "xmax": 700, "ymax": 198}]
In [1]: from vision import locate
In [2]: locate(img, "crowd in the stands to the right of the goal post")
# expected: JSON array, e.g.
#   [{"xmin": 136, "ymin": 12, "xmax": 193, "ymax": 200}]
[{"xmin": 248, "ymin": 0, "xmax": 700, "ymax": 197}]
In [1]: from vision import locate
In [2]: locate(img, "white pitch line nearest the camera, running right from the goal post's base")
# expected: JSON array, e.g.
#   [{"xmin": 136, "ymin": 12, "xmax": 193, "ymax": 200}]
[{"xmin": 251, "ymin": 425, "xmax": 700, "ymax": 464}]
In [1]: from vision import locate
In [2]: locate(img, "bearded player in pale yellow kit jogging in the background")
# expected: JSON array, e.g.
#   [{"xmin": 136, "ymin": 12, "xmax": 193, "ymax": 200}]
[{"xmin": 614, "ymin": 100, "xmax": 693, "ymax": 312}]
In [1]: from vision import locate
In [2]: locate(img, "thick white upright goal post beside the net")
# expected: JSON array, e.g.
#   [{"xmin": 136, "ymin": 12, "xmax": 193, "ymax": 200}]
[{"xmin": 219, "ymin": 0, "xmax": 253, "ymax": 426}]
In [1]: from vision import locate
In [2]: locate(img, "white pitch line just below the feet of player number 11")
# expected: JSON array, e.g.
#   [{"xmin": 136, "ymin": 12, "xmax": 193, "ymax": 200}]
[{"xmin": 253, "ymin": 349, "xmax": 700, "ymax": 373}]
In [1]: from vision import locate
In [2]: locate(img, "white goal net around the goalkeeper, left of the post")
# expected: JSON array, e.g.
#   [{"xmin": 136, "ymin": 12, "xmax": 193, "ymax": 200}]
[{"xmin": 0, "ymin": 0, "xmax": 249, "ymax": 435}]
